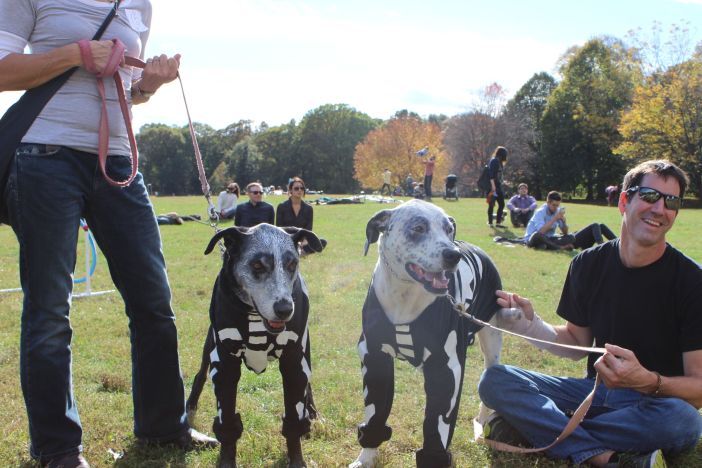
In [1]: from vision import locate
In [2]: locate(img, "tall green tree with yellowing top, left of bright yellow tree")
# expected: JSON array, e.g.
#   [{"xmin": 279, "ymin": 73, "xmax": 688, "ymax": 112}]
[{"xmin": 542, "ymin": 38, "xmax": 640, "ymax": 200}]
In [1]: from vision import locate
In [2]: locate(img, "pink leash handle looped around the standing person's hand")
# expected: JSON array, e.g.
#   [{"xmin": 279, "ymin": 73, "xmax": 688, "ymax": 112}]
[{"xmin": 78, "ymin": 39, "xmax": 145, "ymax": 187}]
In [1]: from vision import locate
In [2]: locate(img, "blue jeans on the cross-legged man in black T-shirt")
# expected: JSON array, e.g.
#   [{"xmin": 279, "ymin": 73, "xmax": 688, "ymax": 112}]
[{"xmin": 478, "ymin": 365, "xmax": 702, "ymax": 465}]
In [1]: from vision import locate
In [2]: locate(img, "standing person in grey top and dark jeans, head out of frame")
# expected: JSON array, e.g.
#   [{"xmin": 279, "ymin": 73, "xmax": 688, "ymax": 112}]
[{"xmin": 0, "ymin": 0, "xmax": 216, "ymax": 467}]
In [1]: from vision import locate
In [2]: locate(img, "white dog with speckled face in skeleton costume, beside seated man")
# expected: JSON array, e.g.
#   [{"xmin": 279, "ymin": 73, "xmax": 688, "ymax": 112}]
[{"xmin": 349, "ymin": 200, "xmax": 502, "ymax": 468}]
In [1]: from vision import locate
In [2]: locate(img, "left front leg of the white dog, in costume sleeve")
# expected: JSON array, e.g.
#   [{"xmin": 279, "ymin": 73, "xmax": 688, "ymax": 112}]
[{"xmin": 349, "ymin": 336, "xmax": 395, "ymax": 468}]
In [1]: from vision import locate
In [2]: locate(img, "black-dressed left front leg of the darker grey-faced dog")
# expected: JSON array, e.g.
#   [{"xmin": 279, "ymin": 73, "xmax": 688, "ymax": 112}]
[{"xmin": 210, "ymin": 345, "xmax": 244, "ymax": 468}]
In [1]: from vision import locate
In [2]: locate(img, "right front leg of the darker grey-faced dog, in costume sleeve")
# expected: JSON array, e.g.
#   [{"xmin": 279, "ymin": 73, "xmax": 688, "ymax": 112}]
[{"xmin": 279, "ymin": 340, "xmax": 312, "ymax": 468}]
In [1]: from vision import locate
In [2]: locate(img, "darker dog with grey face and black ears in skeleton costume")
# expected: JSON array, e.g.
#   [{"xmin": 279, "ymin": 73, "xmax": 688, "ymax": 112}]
[{"xmin": 186, "ymin": 224, "xmax": 322, "ymax": 467}]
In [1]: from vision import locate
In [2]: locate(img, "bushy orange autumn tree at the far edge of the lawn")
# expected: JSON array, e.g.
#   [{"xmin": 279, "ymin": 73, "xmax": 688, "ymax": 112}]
[{"xmin": 354, "ymin": 113, "xmax": 451, "ymax": 190}]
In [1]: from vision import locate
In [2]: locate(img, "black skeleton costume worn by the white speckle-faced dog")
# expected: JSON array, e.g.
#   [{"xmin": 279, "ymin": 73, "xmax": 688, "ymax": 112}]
[{"xmin": 358, "ymin": 241, "xmax": 501, "ymax": 466}]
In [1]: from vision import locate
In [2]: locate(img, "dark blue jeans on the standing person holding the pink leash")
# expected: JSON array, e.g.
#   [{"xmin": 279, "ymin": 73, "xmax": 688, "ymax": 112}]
[{"xmin": 7, "ymin": 144, "xmax": 188, "ymax": 461}]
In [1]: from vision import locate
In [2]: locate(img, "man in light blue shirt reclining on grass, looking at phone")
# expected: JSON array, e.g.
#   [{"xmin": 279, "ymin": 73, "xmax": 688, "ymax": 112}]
[{"xmin": 524, "ymin": 190, "xmax": 617, "ymax": 250}]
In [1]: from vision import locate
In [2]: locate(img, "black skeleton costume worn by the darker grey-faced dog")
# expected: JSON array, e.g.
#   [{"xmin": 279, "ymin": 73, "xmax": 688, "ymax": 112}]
[{"xmin": 210, "ymin": 273, "xmax": 311, "ymax": 444}]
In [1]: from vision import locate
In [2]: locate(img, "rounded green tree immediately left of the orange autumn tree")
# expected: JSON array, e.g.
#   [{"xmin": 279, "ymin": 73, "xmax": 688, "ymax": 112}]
[{"xmin": 297, "ymin": 104, "xmax": 379, "ymax": 193}]
